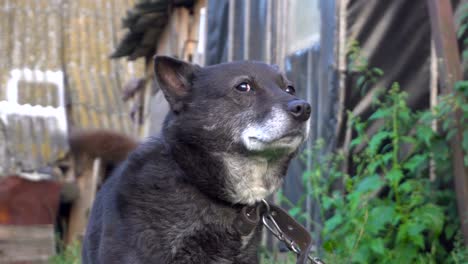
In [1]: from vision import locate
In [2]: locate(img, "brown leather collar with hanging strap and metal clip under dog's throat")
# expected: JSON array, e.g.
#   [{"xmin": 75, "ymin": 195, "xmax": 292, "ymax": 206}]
[{"xmin": 235, "ymin": 200, "xmax": 323, "ymax": 264}]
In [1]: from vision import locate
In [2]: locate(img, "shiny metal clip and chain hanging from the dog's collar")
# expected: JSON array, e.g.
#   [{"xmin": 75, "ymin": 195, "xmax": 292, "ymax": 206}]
[{"xmin": 262, "ymin": 200, "xmax": 325, "ymax": 264}]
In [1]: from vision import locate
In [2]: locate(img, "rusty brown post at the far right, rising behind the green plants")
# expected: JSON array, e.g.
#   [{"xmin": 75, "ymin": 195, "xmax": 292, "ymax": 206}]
[{"xmin": 427, "ymin": 0, "xmax": 468, "ymax": 245}]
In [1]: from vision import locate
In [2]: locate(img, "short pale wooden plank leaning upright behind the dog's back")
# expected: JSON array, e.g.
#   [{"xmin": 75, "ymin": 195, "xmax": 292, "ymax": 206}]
[{"xmin": 65, "ymin": 158, "xmax": 102, "ymax": 245}]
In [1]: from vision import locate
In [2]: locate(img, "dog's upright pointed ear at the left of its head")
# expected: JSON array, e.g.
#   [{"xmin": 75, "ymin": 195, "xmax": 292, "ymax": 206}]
[{"xmin": 154, "ymin": 56, "xmax": 200, "ymax": 113}]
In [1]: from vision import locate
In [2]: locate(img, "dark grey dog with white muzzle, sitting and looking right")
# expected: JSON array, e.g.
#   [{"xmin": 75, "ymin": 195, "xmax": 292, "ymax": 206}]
[{"xmin": 83, "ymin": 57, "xmax": 310, "ymax": 263}]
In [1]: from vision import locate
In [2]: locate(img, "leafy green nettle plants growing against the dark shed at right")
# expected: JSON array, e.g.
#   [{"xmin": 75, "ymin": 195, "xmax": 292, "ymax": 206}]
[{"xmin": 282, "ymin": 43, "xmax": 468, "ymax": 263}]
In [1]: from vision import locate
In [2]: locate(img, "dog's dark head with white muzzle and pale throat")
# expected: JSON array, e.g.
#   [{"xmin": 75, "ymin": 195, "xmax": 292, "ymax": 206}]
[{"xmin": 155, "ymin": 57, "xmax": 311, "ymax": 203}]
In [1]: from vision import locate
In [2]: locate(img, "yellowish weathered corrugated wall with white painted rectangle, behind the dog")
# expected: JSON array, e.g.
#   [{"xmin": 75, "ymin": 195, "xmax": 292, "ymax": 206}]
[{"xmin": 0, "ymin": 0, "xmax": 144, "ymax": 174}]
